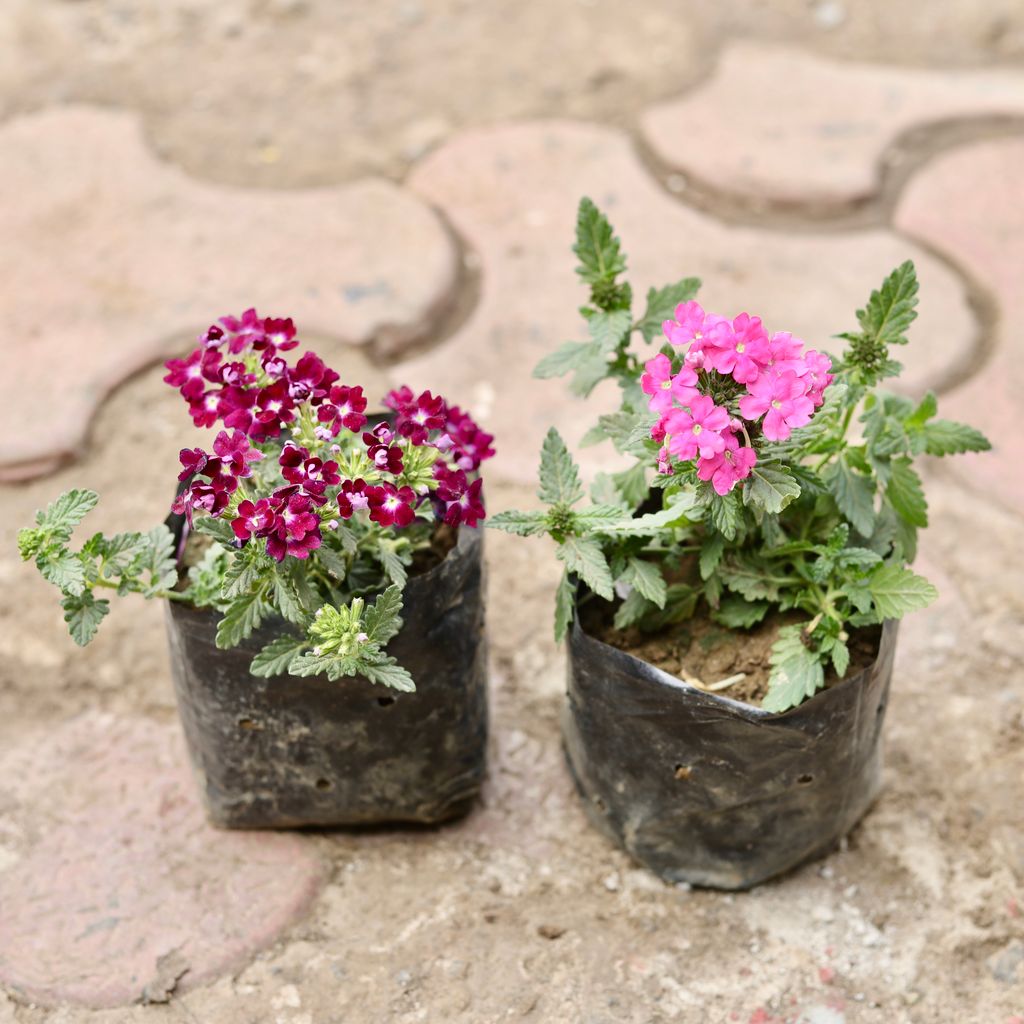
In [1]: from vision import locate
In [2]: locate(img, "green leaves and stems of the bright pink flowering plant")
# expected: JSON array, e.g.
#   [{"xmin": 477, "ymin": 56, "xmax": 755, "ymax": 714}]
[{"xmin": 492, "ymin": 200, "xmax": 989, "ymax": 712}]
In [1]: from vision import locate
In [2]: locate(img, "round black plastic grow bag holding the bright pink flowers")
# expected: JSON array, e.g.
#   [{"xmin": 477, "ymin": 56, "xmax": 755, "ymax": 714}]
[{"xmin": 562, "ymin": 617, "xmax": 898, "ymax": 889}]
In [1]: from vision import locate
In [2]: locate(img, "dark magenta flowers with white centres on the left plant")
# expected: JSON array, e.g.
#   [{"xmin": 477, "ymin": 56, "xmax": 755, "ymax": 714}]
[{"xmin": 164, "ymin": 309, "xmax": 495, "ymax": 561}]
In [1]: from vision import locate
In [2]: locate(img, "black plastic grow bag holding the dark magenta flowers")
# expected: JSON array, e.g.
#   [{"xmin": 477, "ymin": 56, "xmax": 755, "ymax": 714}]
[{"xmin": 167, "ymin": 522, "xmax": 487, "ymax": 828}]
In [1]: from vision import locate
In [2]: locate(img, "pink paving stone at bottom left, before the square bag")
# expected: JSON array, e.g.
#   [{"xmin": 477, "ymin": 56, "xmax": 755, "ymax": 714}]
[{"xmin": 0, "ymin": 714, "xmax": 325, "ymax": 1007}]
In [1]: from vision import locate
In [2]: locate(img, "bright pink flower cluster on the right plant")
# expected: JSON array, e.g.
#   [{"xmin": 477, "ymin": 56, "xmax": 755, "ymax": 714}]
[{"xmin": 640, "ymin": 301, "xmax": 831, "ymax": 495}]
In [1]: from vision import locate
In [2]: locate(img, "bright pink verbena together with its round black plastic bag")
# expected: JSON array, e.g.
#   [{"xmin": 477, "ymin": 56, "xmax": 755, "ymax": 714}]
[{"xmin": 490, "ymin": 200, "xmax": 989, "ymax": 889}]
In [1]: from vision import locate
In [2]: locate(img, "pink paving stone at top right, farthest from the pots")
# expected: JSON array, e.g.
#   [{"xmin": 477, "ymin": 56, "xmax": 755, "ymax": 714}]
[{"xmin": 641, "ymin": 42, "xmax": 1024, "ymax": 206}]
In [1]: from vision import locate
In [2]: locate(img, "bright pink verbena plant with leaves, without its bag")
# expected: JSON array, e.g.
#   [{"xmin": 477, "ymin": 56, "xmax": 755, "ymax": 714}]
[{"xmin": 490, "ymin": 199, "xmax": 989, "ymax": 712}]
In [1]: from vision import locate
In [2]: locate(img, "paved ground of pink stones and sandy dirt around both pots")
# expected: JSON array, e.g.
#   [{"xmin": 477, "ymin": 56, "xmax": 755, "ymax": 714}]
[{"xmin": 0, "ymin": 8, "xmax": 1024, "ymax": 1024}]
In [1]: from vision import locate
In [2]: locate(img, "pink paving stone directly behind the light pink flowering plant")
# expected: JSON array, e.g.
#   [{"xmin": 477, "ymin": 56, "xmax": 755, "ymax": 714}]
[{"xmin": 394, "ymin": 121, "xmax": 977, "ymax": 481}]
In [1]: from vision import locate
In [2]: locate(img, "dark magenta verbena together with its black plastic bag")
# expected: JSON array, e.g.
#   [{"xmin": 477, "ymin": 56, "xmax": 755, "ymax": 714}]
[{"xmin": 18, "ymin": 309, "xmax": 494, "ymax": 827}]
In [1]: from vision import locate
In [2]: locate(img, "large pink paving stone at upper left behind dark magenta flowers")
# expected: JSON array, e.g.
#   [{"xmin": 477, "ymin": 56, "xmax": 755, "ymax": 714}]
[{"xmin": 0, "ymin": 108, "xmax": 457, "ymax": 480}]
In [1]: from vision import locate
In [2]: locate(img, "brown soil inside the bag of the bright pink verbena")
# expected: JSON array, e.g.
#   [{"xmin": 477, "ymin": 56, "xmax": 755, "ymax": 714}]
[{"xmin": 581, "ymin": 601, "xmax": 881, "ymax": 707}]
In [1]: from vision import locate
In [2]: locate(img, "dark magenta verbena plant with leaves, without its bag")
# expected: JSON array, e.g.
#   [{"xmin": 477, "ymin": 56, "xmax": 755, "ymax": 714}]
[{"xmin": 18, "ymin": 309, "xmax": 494, "ymax": 690}]
